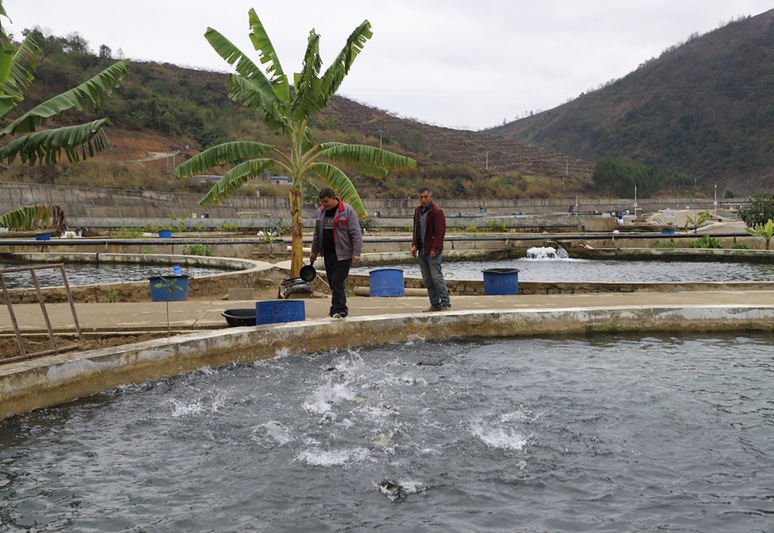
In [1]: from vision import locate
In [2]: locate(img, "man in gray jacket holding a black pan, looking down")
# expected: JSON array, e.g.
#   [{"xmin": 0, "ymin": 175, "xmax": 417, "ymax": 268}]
[{"xmin": 309, "ymin": 189, "xmax": 363, "ymax": 318}]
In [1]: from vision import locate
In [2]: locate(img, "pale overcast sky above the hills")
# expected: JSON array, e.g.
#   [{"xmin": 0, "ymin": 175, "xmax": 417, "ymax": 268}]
[{"xmin": 2, "ymin": 0, "xmax": 772, "ymax": 130}]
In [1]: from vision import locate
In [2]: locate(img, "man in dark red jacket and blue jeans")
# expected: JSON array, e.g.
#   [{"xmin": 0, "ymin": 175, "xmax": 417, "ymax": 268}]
[{"xmin": 411, "ymin": 187, "xmax": 451, "ymax": 312}]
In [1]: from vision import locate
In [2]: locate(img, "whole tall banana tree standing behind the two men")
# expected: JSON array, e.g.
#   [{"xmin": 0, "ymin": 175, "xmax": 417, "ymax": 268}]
[{"xmin": 174, "ymin": 9, "xmax": 416, "ymax": 277}]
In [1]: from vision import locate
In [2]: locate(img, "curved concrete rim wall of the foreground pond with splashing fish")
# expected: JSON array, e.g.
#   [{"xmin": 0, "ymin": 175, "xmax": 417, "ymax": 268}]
[{"xmin": 0, "ymin": 305, "xmax": 774, "ymax": 420}]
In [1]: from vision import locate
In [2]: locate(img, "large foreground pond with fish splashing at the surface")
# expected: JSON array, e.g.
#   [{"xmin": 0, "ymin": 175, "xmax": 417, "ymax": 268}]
[{"xmin": 0, "ymin": 334, "xmax": 774, "ymax": 533}]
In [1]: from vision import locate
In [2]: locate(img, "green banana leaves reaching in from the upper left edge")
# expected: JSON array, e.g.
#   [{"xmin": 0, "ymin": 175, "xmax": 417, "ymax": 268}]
[{"xmin": 0, "ymin": 0, "xmax": 129, "ymax": 166}]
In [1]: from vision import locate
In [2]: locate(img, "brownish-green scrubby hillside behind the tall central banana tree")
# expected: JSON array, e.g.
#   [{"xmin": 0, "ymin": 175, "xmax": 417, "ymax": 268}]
[{"xmin": 0, "ymin": 29, "xmax": 594, "ymax": 198}]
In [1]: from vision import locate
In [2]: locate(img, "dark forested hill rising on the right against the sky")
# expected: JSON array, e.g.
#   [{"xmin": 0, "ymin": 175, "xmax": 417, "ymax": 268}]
[{"xmin": 489, "ymin": 10, "xmax": 774, "ymax": 193}]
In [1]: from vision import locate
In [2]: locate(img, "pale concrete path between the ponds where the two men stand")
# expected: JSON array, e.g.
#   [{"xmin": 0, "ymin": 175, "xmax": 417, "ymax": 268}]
[{"xmin": 0, "ymin": 291, "xmax": 774, "ymax": 335}]
